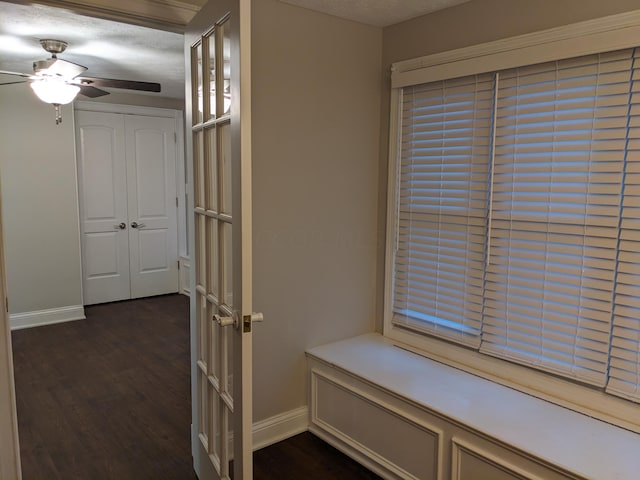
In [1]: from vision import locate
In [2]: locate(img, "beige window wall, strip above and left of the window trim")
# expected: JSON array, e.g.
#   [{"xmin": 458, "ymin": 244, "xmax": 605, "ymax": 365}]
[{"xmin": 377, "ymin": 0, "xmax": 640, "ymax": 329}]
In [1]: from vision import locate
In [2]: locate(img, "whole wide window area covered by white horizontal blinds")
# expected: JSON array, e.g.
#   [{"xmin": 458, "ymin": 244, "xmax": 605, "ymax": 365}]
[{"xmin": 392, "ymin": 49, "xmax": 640, "ymax": 401}]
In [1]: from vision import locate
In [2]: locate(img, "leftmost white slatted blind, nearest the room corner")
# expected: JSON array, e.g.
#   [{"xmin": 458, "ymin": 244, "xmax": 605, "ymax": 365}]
[{"xmin": 393, "ymin": 74, "xmax": 493, "ymax": 346}]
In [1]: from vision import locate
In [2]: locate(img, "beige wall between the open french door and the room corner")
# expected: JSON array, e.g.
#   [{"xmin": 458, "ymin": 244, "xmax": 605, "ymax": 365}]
[{"xmin": 252, "ymin": 0, "xmax": 382, "ymax": 421}]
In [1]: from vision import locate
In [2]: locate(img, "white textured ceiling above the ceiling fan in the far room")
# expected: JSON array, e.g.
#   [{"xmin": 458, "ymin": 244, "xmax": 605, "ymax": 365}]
[{"xmin": 0, "ymin": 2, "xmax": 184, "ymax": 98}]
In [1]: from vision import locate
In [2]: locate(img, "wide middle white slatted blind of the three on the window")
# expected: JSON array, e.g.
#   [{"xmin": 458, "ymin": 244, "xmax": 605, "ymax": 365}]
[{"xmin": 481, "ymin": 51, "xmax": 631, "ymax": 386}]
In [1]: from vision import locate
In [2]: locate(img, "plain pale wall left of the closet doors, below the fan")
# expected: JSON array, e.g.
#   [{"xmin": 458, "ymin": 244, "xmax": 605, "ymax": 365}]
[{"xmin": 0, "ymin": 84, "xmax": 82, "ymax": 313}]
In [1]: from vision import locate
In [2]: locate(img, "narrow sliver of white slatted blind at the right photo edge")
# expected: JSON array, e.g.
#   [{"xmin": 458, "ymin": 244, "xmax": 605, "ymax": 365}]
[{"xmin": 607, "ymin": 49, "xmax": 640, "ymax": 400}]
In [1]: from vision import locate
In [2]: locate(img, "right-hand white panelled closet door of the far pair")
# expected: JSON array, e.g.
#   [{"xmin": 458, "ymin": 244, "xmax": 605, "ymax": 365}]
[{"xmin": 125, "ymin": 115, "xmax": 178, "ymax": 298}]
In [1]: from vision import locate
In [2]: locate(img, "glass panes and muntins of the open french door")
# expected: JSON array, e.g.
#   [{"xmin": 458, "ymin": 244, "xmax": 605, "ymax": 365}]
[{"xmin": 191, "ymin": 15, "xmax": 234, "ymax": 479}]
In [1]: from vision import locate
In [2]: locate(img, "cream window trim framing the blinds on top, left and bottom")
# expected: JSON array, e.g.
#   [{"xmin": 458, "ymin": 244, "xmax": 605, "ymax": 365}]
[{"xmin": 383, "ymin": 10, "xmax": 640, "ymax": 433}]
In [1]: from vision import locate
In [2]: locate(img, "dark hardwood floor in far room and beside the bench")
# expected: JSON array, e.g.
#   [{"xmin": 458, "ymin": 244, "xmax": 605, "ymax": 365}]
[{"xmin": 11, "ymin": 295, "xmax": 379, "ymax": 480}]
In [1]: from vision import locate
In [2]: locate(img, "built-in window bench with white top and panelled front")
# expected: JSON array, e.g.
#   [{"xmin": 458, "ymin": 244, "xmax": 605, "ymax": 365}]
[{"xmin": 307, "ymin": 334, "xmax": 640, "ymax": 480}]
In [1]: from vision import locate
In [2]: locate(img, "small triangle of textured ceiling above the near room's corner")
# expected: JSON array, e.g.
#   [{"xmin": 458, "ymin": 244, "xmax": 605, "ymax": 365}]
[{"xmin": 280, "ymin": 0, "xmax": 470, "ymax": 27}]
